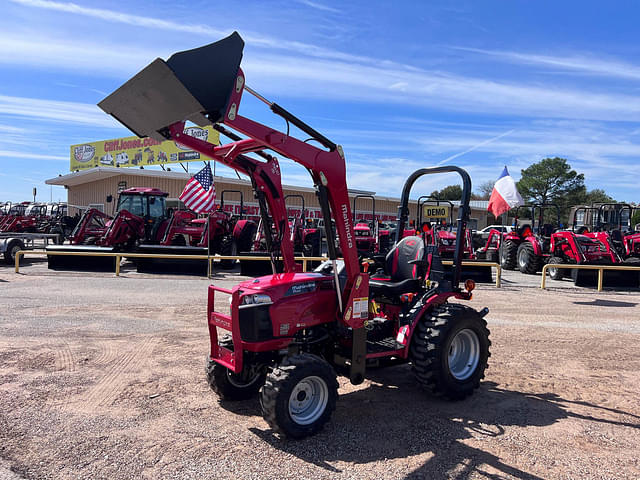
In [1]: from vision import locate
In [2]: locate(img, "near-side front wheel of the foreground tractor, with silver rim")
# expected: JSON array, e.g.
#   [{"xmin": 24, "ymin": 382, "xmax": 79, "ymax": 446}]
[{"xmin": 260, "ymin": 353, "xmax": 338, "ymax": 438}]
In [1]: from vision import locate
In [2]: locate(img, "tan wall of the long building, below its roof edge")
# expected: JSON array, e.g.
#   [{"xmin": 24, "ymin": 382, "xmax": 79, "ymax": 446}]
[{"xmin": 68, "ymin": 173, "xmax": 488, "ymax": 228}]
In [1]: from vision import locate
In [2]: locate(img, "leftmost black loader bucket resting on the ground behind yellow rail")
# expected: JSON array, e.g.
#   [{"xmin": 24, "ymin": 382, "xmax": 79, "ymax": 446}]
[{"xmin": 46, "ymin": 245, "xmax": 116, "ymax": 272}]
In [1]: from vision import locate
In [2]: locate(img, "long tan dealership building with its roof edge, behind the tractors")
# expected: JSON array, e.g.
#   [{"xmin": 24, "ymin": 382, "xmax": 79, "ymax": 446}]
[{"xmin": 46, "ymin": 166, "xmax": 492, "ymax": 229}]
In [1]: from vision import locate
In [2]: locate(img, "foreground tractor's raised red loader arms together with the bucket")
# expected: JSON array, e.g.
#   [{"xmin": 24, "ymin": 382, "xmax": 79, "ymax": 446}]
[{"xmin": 99, "ymin": 33, "xmax": 369, "ymax": 326}]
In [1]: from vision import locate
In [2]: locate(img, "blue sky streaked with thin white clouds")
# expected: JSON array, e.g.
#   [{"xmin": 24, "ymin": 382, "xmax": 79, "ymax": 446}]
[{"xmin": 0, "ymin": 0, "xmax": 640, "ymax": 202}]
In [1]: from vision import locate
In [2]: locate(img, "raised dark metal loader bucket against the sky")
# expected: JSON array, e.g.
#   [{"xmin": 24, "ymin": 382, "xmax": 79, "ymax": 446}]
[{"xmin": 98, "ymin": 32, "xmax": 244, "ymax": 141}]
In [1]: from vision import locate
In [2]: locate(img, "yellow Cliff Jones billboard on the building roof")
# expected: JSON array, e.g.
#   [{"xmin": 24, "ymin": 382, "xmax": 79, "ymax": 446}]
[{"xmin": 69, "ymin": 126, "xmax": 220, "ymax": 172}]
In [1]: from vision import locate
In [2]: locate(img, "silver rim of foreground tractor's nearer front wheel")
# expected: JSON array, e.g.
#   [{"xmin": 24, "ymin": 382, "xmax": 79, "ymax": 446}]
[{"xmin": 289, "ymin": 376, "xmax": 329, "ymax": 425}]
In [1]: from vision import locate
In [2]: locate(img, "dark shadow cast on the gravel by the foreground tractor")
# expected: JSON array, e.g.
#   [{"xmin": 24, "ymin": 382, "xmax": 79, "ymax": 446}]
[{"xmin": 243, "ymin": 366, "xmax": 640, "ymax": 480}]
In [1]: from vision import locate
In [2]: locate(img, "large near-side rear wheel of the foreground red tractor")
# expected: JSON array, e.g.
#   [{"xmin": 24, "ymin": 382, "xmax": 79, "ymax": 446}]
[{"xmin": 410, "ymin": 303, "xmax": 491, "ymax": 400}]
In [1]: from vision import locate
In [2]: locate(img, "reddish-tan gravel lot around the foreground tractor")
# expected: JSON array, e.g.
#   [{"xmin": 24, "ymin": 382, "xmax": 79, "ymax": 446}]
[{"xmin": 0, "ymin": 262, "xmax": 640, "ymax": 479}]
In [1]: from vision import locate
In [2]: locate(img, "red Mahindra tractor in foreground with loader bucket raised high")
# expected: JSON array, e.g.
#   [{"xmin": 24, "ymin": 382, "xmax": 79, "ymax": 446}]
[{"xmin": 99, "ymin": 33, "xmax": 490, "ymax": 438}]
